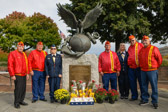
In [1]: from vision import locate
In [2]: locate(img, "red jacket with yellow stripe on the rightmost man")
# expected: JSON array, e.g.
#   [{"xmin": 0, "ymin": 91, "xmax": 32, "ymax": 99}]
[{"xmin": 139, "ymin": 45, "xmax": 162, "ymax": 71}]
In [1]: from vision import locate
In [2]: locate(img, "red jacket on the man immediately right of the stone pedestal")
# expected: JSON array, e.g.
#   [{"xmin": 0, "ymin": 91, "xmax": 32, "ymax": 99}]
[{"xmin": 99, "ymin": 51, "xmax": 121, "ymax": 73}]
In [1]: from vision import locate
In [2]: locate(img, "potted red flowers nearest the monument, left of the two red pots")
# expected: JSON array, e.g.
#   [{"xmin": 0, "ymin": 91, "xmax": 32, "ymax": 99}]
[{"xmin": 95, "ymin": 88, "xmax": 107, "ymax": 103}]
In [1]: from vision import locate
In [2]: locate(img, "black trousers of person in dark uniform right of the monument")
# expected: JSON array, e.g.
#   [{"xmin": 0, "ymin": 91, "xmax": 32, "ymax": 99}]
[{"xmin": 118, "ymin": 71, "xmax": 129, "ymax": 97}]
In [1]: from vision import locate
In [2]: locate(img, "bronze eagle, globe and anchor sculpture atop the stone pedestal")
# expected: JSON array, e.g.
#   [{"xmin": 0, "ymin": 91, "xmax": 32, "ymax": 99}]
[{"xmin": 56, "ymin": 3, "xmax": 102, "ymax": 57}]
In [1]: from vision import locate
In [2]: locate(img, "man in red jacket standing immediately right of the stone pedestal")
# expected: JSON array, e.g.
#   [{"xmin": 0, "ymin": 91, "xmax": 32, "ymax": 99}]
[{"xmin": 99, "ymin": 41, "xmax": 121, "ymax": 91}]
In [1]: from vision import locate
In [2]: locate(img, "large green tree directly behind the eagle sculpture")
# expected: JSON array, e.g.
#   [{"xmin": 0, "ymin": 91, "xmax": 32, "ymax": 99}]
[{"xmin": 62, "ymin": 0, "xmax": 165, "ymax": 51}]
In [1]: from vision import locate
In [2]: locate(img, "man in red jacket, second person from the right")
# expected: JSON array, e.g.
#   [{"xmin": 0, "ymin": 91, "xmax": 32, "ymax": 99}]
[{"xmin": 128, "ymin": 35, "xmax": 143, "ymax": 101}]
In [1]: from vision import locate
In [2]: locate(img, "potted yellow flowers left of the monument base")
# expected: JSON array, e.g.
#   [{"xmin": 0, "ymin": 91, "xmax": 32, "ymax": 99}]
[{"xmin": 54, "ymin": 89, "xmax": 70, "ymax": 104}]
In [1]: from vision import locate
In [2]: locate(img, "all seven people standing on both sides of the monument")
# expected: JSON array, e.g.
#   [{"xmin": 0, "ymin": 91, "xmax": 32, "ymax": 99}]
[{"xmin": 8, "ymin": 35, "xmax": 162, "ymax": 108}]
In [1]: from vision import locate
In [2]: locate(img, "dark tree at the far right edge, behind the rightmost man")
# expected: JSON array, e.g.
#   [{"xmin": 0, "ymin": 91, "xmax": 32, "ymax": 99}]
[{"xmin": 142, "ymin": 0, "xmax": 168, "ymax": 44}]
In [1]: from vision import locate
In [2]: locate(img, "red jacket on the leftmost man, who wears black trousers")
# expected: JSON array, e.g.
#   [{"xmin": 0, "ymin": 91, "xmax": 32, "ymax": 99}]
[{"xmin": 8, "ymin": 50, "xmax": 29, "ymax": 76}]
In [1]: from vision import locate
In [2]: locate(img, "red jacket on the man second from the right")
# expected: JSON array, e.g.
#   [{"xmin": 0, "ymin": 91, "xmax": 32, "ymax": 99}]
[{"xmin": 128, "ymin": 42, "xmax": 143, "ymax": 68}]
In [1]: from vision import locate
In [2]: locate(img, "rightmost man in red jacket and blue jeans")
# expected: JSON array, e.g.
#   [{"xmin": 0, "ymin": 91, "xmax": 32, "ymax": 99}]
[{"xmin": 139, "ymin": 36, "xmax": 162, "ymax": 109}]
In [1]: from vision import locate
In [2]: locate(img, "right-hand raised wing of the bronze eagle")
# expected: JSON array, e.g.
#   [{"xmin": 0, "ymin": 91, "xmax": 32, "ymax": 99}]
[{"xmin": 82, "ymin": 4, "xmax": 102, "ymax": 29}]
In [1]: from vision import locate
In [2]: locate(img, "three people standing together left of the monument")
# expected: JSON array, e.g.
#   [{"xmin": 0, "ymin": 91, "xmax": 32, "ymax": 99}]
[{"xmin": 8, "ymin": 42, "xmax": 62, "ymax": 108}]
